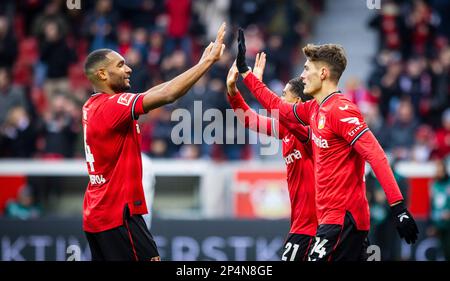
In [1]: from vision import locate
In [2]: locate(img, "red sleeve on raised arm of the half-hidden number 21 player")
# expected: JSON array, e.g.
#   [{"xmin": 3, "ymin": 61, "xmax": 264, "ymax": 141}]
[{"xmin": 227, "ymin": 89, "xmax": 279, "ymax": 138}]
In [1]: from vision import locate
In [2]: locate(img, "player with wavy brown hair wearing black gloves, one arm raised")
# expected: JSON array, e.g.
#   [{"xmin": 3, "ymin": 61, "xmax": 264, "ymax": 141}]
[{"xmin": 236, "ymin": 29, "xmax": 418, "ymax": 261}]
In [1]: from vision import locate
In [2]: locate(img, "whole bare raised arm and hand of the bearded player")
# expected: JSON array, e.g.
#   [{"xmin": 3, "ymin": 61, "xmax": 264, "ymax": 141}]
[{"xmin": 143, "ymin": 23, "xmax": 226, "ymax": 112}]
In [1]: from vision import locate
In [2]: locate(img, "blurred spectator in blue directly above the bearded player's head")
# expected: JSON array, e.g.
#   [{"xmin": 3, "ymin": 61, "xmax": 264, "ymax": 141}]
[{"xmin": 83, "ymin": 0, "xmax": 118, "ymax": 51}]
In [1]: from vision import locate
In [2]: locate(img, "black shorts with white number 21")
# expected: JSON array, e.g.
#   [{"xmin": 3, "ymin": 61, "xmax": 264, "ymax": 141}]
[{"xmin": 281, "ymin": 233, "xmax": 314, "ymax": 261}]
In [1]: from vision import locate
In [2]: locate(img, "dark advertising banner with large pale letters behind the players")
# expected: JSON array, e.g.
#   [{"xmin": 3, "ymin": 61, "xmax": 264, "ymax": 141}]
[{"xmin": 0, "ymin": 218, "xmax": 442, "ymax": 261}]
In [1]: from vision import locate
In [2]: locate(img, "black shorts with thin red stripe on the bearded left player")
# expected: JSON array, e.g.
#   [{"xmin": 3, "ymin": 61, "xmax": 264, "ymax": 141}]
[{"xmin": 85, "ymin": 205, "xmax": 159, "ymax": 261}]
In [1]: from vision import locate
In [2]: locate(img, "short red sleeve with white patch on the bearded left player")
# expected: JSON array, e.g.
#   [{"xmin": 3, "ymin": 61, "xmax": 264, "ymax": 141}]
[{"xmin": 102, "ymin": 93, "xmax": 144, "ymax": 128}]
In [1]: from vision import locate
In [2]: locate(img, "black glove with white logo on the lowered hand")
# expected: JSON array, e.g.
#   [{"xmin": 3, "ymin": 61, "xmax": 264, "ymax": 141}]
[{"xmin": 391, "ymin": 202, "xmax": 419, "ymax": 244}]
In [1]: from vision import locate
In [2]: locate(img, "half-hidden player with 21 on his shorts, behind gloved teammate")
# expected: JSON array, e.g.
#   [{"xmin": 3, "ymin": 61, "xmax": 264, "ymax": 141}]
[{"xmin": 227, "ymin": 58, "xmax": 317, "ymax": 261}]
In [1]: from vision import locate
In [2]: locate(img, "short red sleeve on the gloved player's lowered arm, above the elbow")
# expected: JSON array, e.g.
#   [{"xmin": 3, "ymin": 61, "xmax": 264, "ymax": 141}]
[{"xmin": 329, "ymin": 100, "xmax": 369, "ymax": 145}]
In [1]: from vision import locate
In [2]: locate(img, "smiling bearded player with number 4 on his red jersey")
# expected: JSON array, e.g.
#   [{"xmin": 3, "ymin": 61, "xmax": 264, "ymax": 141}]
[{"xmin": 83, "ymin": 23, "xmax": 225, "ymax": 261}]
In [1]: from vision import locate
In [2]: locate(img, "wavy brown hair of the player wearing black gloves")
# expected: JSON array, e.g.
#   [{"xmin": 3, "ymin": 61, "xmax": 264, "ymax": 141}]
[{"xmin": 303, "ymin": 44, "xmax": 347, "ymax": 82}]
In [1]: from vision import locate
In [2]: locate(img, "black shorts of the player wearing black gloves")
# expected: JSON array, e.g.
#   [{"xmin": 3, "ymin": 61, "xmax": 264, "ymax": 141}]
[{"xmin": 308, "ymin": 212, "xmax": 369, "ymax": 261}]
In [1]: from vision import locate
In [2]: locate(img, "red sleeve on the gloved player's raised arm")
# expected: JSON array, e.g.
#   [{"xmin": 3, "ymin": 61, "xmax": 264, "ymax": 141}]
[{"xmin": 244, "ymin": 72, "xmax": 312, "ymax": 125}]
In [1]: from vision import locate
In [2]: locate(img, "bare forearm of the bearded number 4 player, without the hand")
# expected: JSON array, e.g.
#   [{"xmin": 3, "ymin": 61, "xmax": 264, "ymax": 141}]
[{"xmin": 143, "ymin": 59, "xmax": 214, "ymax": 112}]
